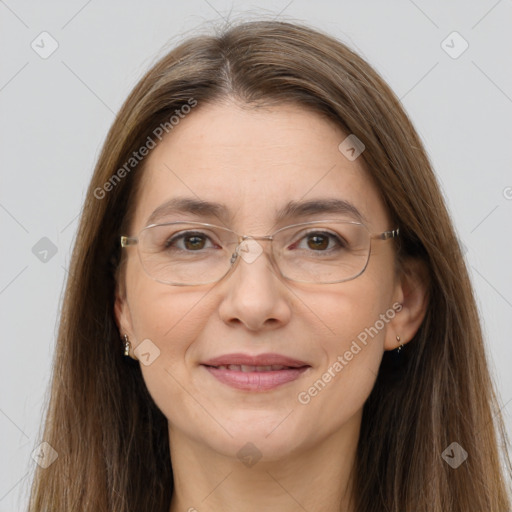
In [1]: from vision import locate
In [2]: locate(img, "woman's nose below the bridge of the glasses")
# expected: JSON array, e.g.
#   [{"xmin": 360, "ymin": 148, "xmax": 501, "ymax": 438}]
[{"xmin": 219, "ymin": 240, "xmax": 291, "ymax": 331}]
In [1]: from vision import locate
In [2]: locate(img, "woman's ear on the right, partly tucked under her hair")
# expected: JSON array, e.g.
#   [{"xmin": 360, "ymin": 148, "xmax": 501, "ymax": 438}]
[{"xmin": 384, "ymin": 258, "xmax": 429, "ymax": 350}]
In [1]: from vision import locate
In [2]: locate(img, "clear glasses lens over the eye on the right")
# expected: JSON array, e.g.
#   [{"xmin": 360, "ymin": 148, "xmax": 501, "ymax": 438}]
[{"xmin": 274, "ymin": 221, "xmax": 370, "ymax": 283}]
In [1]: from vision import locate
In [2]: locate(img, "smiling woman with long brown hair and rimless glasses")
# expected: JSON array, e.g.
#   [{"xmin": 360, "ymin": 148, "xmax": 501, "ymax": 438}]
[{"xmin": 30, "ymin": 22, "xmax": 510, "ymax": 512}]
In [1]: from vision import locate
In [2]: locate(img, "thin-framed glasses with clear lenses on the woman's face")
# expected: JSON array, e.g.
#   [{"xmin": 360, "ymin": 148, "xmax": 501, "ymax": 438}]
[{"xmin": 121, "ymin": 220, "xmax": 399, "ymax": 286}]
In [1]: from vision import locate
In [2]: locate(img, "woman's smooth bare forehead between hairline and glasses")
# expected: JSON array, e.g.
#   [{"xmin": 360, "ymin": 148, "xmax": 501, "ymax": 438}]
[{"xmin": 133, "ymin": 102, "xmax": 388, "ymax": 233}]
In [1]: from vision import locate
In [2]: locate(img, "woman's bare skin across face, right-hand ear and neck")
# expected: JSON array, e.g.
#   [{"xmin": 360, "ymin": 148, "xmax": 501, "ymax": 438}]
[{"xmin": 115, "ymin": 100, "xmax": 426, "ymax": 512}]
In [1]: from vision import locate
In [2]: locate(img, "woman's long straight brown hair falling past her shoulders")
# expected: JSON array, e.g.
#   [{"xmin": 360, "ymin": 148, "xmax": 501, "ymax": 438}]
[{"xmin": 30, "ymin": 21, "xmax": 510, "ymax": 512}]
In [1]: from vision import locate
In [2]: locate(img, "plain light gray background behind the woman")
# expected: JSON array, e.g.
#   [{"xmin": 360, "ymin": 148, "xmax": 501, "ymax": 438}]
[{"xmin": 0, "ymin": 0, "xmax": 512, "ymax": 512}]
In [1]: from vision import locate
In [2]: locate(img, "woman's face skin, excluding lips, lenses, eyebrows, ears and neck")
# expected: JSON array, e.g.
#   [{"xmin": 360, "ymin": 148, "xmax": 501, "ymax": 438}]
[{"xmin": 116, "ymin": 103, "xmax": 403, "ymax": 460}]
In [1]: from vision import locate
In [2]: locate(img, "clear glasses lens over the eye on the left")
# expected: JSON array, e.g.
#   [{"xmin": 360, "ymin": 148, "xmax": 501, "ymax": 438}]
[{"xmin": 139, "ymin": 223, "xmax": 237, "ymax": 285}]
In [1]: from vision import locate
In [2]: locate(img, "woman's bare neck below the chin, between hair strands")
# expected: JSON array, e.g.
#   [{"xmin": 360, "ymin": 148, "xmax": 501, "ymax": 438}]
[{"xmin": 169, "ymin": 414, "xmax": 361, "ymax": 512}]
